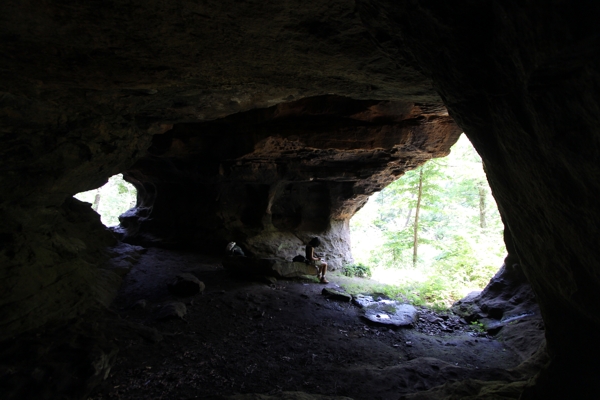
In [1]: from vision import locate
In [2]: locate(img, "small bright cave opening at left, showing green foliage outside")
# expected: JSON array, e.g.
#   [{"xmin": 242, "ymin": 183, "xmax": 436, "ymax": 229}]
[{"xmin": 73, "ymin": 174, "xmax": 137, "ymax": 227}]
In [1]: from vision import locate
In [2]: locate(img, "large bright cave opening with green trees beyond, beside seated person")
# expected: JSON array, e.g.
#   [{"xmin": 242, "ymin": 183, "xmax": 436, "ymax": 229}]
[{"xmin": 344, "ymin": 135, "xmax": 506, "ymax": 309}]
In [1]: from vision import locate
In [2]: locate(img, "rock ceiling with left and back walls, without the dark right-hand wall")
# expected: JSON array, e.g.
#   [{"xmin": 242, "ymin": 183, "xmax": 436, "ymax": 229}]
[{"xmin": 0, "ymin": 1, "xmax": 459, "ymax": 344}]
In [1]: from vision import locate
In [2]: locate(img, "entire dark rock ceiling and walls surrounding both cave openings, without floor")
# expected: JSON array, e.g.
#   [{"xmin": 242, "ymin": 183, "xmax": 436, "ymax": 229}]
[{"xmin": 0, "ymin": 0, "xmax": 600, "ymax": 398}]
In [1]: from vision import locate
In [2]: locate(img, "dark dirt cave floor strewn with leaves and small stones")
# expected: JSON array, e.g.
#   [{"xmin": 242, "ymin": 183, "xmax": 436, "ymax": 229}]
[{"xmin": 89, "ymin": 248, "xmax": 536, "ymax": 400}]
